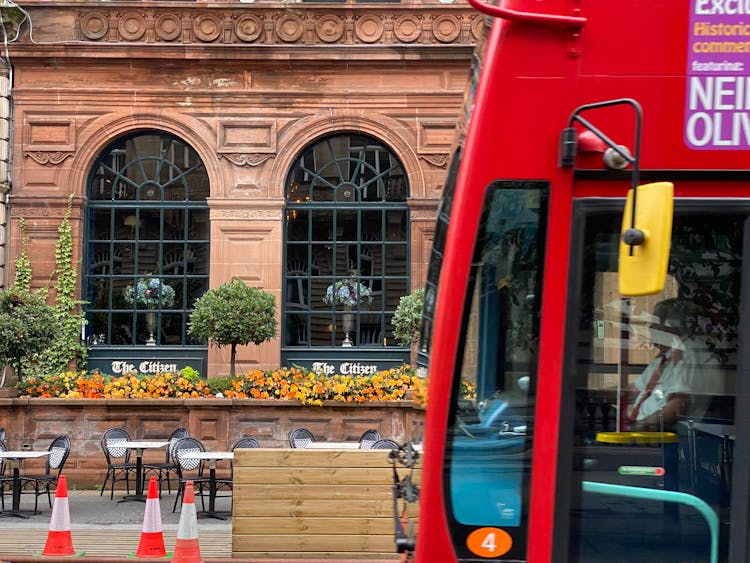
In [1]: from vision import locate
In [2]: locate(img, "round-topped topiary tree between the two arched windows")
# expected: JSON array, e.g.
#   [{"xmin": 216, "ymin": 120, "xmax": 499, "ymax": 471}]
[{"xmin": 188, "ymin": 278, "xmax": 278, "ymax": 377}]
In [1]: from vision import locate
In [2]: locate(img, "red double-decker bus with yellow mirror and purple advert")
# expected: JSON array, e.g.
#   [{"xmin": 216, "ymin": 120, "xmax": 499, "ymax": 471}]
[{"xmin": 404, "ymin": 0, "xmax": 750, "ymax": 563}]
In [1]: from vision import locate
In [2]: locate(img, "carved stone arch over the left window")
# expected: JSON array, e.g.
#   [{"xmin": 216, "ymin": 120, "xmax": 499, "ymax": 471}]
[{"xmin": 70, "ymin": 114, "xmax": 222, "ymax": 198}]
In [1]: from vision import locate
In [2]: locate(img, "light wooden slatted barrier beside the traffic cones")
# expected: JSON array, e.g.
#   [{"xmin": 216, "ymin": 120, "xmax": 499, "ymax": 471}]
[{"xmin": 232, "ymin": 448, "xmax": 419, "ymax": 560}]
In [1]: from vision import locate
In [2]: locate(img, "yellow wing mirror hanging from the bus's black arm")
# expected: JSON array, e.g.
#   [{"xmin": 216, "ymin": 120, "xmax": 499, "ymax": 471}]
[{"xmin": 620, "ymin": 182, "xmax": 674, "ymax": 296}]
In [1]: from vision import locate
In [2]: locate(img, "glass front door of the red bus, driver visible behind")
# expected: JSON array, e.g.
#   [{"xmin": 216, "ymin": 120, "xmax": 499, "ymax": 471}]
[{"xmin": 568, "ymin": 199, "xmax": 750, "ymax": 563}]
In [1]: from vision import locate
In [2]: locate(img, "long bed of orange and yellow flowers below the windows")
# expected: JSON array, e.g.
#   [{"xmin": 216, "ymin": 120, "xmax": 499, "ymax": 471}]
[{"xmin": 18, "ymin": 364, "xmax": 416, "ymax": 406}]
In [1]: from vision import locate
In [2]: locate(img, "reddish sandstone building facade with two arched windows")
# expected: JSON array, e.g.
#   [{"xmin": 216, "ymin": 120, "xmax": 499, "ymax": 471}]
[{"xmin": 0, "ymin": 0, "xmax": 484, "ymax": 376}]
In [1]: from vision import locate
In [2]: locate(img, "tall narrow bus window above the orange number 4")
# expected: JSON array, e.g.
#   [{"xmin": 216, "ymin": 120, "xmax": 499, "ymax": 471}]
[{"xmin": 445, "ymin": 182, "xmax": 548, "ymax": 559}]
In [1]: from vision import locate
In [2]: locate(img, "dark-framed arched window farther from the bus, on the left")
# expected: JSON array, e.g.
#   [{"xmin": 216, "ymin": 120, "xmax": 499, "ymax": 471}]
[{"xmin": 83, "ymin": 131, "xmax": 209, "ymax": 347}]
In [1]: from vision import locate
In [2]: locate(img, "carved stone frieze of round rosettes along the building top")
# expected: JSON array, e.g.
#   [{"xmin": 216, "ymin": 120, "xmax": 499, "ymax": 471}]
[{"xmin": 76, "ymin": 7, "xmax": 484, "ymax": 45}]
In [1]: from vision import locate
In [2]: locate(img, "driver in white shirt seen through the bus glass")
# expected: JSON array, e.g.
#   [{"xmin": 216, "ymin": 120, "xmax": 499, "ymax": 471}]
[{"xmin": 626, "ymin": 298, "xmax": 695, "ymax": 431}]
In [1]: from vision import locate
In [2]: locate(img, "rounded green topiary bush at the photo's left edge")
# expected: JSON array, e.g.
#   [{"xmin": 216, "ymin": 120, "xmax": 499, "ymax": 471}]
[{"xmin": 0, "ymin": 287, "xmax": 58, "ymax": 392}]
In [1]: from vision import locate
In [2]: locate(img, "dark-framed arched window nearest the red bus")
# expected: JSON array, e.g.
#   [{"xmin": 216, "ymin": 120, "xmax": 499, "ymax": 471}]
[{"xmin": 282, "ymin": 133, "xmax": 409, "ymax": 352}]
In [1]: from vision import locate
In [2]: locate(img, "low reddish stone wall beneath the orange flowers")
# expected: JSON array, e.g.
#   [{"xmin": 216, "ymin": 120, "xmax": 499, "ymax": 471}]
[{"xmin": 0, "ymin": 398, "xmax": 423, "ymax": 488}]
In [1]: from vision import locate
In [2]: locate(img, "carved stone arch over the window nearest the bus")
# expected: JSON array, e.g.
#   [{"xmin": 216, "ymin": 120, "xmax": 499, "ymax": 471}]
[{"xmin": 269, "ymin": 110, "xmax": 426, "ymax": 198}]
